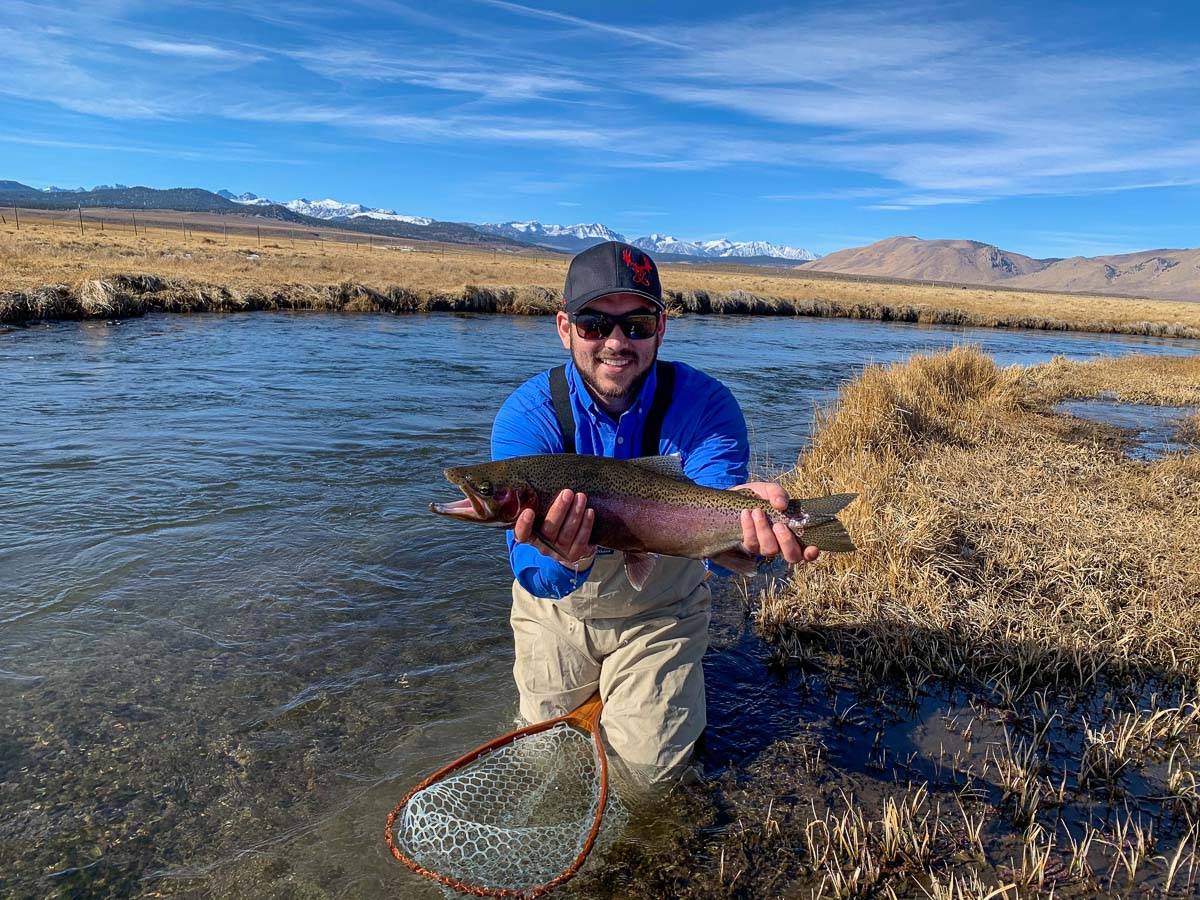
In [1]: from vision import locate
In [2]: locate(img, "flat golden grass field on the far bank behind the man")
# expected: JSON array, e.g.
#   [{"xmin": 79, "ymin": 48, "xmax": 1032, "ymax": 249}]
[{"xmin": 7, "ymin": 212, "xmax": 1200, "ymax": 338}]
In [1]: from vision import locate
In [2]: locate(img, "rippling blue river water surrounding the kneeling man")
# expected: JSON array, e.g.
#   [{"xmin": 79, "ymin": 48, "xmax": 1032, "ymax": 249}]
[{"xmin": 0, "ymin": 313, "xmax": 1193, "ymax": 896}]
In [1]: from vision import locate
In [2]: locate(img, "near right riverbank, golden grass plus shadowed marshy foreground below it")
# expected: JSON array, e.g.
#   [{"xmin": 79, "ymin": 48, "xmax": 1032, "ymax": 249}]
[{"xmin": 581, "ymin": 348, "xmax": 1200, "ymax": 900}]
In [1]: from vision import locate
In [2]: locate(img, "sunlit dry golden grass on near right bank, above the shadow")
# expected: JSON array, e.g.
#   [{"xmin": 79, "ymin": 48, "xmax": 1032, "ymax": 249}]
[{"xmin": 760, "ymin": 348, "xmax": 1200, "ymax": 686}]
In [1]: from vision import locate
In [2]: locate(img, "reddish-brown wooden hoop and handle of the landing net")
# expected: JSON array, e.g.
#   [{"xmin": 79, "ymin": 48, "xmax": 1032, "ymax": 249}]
[{"xmin": 384, "ymin": 691, "xmax": 608, "ymax": 900}]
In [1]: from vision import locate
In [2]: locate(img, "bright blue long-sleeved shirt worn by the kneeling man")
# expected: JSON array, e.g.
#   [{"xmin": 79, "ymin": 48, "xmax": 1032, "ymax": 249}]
[{"xmin": 492, "ymin": 361, "xmax": 750, "ymax": 599}]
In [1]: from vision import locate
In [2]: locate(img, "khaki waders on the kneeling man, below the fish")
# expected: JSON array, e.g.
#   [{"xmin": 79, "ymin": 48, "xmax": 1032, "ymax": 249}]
[{"xmin": 511, "ymin": 552, "xmax": 712, "ymax": 782}]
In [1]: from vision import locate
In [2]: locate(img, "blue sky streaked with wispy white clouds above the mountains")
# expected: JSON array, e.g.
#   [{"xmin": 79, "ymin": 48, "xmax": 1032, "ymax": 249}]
[{"xmin": 0, "ymin": 0, "xmax": 1200, "ymax": 257}]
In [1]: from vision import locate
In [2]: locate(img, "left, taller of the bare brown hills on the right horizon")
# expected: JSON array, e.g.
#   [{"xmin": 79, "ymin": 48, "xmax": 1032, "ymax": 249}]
[{"xmin": 799, "ymin": 236, "xmax": 1046, "ymax": 284}]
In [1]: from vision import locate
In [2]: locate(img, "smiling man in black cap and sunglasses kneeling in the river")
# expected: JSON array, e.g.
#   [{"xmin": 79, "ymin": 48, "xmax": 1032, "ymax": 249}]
[{"xmin": 492, "ymin": 241, "xmax": 817, "ymax": 782}]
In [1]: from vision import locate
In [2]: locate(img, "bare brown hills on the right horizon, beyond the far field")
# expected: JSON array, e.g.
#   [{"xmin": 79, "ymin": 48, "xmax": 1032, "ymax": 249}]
[{"xmin": 797, "ymin": 236, "xmax": 1200, "ymax": 300}]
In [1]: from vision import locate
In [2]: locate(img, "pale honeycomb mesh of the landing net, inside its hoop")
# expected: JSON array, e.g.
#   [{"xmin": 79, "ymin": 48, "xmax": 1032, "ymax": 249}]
[{"xmin": 394, "ymin": 721, "xmax": 623, "ymax": 896}]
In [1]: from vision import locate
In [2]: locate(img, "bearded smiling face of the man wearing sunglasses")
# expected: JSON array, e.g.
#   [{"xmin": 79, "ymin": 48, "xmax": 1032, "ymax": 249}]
[{"xmin": 558, "ymin": 294, "xmax": 666, "ymax": 412}]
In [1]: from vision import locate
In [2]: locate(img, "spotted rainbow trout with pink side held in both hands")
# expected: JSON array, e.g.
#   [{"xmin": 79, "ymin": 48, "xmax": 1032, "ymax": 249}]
[{"xmin": 430, "ymin": 454, "xmax": 858, "ymax": 590}]
